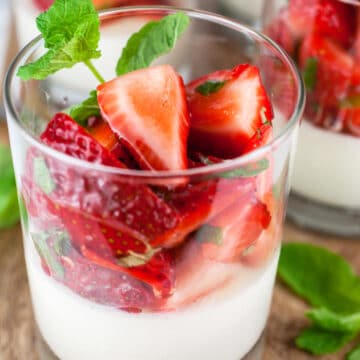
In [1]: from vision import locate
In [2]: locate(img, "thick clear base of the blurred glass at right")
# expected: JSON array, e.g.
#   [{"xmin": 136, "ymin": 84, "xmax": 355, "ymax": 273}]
[{"xmin": 287, "ymin": 192, "xmax": 360, "ymax": 237}]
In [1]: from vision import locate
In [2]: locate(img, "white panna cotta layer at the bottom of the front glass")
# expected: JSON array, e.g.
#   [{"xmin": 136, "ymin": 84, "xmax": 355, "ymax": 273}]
[{"xmin": 26, "ymin": 239, "xmax": 279, "ymax": 360}]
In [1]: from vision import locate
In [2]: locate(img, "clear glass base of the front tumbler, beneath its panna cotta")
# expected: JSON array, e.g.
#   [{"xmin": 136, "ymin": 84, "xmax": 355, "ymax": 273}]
[{"xmin": 35, "ymin": 327, "xmax": 265, "ymax": 360}]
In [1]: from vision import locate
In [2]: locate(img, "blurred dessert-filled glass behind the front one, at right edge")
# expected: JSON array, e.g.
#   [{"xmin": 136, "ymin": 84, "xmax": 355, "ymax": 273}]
[{"xmin": 263, "ymin": 0, "xmax": 360, "ymax": 236}]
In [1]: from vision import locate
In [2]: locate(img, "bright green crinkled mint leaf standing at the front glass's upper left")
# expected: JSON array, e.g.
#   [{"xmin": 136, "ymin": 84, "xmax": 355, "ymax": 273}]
[{"xmin": 17, "ymin": 0, "xmax": 100, "ymax": 80}]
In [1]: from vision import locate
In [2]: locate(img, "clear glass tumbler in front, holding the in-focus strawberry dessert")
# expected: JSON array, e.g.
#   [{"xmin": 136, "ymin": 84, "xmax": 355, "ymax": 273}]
[{"xmin": 5, "ymin": 7, "xmax": 304, "ymax": 360}]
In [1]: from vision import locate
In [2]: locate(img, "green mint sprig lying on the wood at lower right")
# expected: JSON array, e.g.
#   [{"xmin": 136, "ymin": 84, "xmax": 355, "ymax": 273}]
[{"xmin": 278, "ymin": 243, "xmax": 360, "ymax": 360}]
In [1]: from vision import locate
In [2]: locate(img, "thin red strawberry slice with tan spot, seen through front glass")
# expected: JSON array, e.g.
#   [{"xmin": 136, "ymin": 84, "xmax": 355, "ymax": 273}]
[{"xmin": 58, "ymin": 207, "xmax": 175, "ymax": 297}]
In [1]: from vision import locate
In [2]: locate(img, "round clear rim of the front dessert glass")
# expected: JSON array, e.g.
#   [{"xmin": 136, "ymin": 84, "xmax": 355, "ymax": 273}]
[{"xmin": 3, "ymin": 6, "xmax": 305, "ymax": 180}]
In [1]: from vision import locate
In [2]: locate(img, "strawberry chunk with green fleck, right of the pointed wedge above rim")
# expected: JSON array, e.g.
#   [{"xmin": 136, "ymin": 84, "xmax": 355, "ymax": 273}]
[{"xmin": 187, "ymin": 64, "xmax": 273, "ymax": 158}]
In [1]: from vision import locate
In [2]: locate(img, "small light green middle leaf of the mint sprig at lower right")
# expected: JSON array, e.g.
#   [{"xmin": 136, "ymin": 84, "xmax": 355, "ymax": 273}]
[{"xmin": 306, "ymin": 308, "xmax": 360, "ymax": 332}]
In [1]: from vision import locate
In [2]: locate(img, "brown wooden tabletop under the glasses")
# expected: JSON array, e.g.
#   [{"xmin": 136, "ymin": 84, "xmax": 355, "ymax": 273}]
[{"xmin": 0, "ymin": 122, "xmax": 360, "ymax": 360}]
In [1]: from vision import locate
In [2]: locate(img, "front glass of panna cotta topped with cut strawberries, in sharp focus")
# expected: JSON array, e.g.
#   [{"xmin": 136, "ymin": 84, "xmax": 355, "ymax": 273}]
[{"xmin": 5, "ymin": 3, "xmax": 304, "ymax": 360}]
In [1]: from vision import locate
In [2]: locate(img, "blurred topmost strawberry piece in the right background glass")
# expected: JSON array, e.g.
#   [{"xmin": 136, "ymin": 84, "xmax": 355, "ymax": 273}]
[{"xmin": 287, "ymin": 0, "xmax": 355, "ymax": 46}]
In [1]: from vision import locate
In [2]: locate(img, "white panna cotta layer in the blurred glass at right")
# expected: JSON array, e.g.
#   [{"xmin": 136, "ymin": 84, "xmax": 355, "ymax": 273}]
[{"xmin": 292, "ymin": 120, "xmax": 360, "ymax": 209}]
